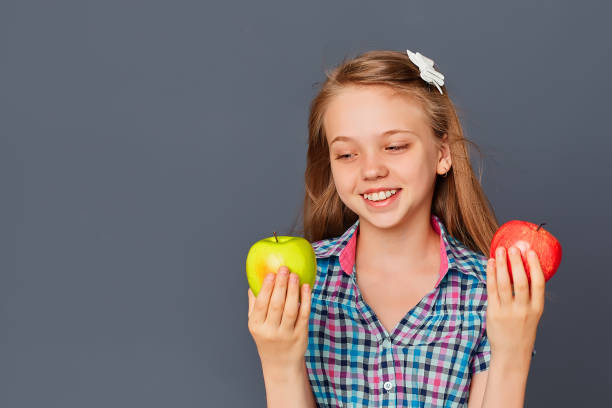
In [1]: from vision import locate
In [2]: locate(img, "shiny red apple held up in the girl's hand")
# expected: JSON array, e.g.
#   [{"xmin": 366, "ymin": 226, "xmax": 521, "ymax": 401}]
[{"xmin": 489, "ymin": 220, "xmax": 562, "ymax": 283}]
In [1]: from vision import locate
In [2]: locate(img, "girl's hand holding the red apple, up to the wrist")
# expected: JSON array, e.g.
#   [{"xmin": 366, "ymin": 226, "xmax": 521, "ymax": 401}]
[{"xmin": 485, "ymin": 247, "xmax": 545, "ymax": 358}]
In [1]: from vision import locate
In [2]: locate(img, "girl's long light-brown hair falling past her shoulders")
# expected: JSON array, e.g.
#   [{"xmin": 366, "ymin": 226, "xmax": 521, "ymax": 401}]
[{"xmin": 293, "ymin": 50, "xmax": 498, "ymax": 256}]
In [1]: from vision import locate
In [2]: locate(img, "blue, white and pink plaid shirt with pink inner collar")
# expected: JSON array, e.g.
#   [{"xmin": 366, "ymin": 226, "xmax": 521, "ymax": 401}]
[{"xmin": 305, "ymin": 214, "xmax": 500, "ymax": 408}]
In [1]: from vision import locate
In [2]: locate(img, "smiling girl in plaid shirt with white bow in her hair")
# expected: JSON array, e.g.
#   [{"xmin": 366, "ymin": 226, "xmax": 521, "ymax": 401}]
[{"xmin": 248, "ymin": 50, "xmax": 544, "ymax": 408}]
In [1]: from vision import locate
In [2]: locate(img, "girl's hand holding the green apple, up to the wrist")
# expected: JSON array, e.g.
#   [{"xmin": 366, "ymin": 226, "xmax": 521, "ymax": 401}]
[{"xmin": 248, "ymin": 266, "xmax": 311, "ymax": 370}]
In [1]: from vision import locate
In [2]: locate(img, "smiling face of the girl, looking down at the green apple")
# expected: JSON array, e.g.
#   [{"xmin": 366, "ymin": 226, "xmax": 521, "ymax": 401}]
[{"xmin": 324, "ymin": 86, "xmax": 451, "ymax": 228}]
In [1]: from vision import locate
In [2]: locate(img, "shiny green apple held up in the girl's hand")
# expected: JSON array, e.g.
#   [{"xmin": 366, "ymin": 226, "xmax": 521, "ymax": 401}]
[{"xmin": 246, "ymin": 232, "xmax": 317, "ymax": 296}]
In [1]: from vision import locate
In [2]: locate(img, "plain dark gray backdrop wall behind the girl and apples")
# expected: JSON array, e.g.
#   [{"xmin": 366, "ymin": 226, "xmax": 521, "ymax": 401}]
[{"xmin": 0, "ymin": 0, "xmax": 612, "ymax": 408}]
